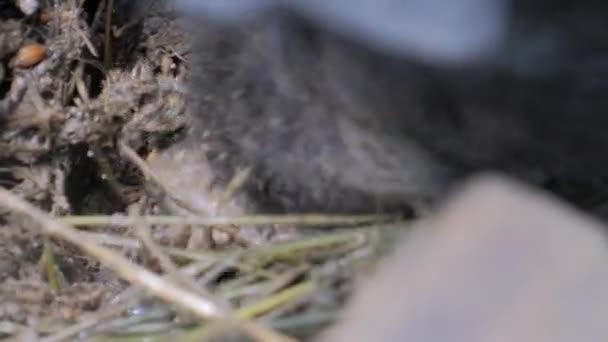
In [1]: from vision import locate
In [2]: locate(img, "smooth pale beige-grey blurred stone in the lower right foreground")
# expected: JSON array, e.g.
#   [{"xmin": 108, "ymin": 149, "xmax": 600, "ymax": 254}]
[{"xmin": 322, "ymin": 177, "xmax": 608, "ymax": 342}]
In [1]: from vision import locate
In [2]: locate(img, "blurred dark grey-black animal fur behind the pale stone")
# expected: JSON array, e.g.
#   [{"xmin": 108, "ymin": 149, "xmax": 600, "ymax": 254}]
[{"xmin": 192, "ymin": 1, "xmax": 608, "ymax": 212}]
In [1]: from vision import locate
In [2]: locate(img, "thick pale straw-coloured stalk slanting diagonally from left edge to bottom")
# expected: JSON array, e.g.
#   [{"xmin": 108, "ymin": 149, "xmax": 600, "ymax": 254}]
[{"xmin": 0, "ymin": 188, "xmax": 293, "ymax": 341}]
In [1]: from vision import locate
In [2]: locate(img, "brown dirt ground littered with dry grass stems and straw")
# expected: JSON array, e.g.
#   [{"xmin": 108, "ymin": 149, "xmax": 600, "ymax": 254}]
[{"xmin": 0, "ymin": 0, "xmax": 408, "ymax": 341}]
